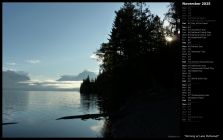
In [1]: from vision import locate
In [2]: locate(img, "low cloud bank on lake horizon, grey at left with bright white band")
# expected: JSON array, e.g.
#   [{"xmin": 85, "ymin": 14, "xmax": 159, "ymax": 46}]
[{"xmin": 3, "ymin": 70, "xmax": 82, "ymax": 91}]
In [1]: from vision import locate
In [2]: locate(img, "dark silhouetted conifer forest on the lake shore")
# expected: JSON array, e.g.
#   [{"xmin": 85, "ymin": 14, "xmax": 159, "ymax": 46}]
[{"xmin": 80, "ymin": 2, "xmax": 181, "ymax": 113}]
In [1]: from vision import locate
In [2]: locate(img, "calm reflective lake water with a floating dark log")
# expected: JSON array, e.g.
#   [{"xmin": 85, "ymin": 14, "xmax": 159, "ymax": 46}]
[{"xmin": 2, "ymin": 90, "xmax": 104, "ymax": 137}]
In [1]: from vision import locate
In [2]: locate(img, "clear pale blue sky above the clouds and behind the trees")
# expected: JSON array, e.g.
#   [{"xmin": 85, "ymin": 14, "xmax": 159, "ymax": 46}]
[{"xmin": 2, "ymin": 2, "xmax": 169, "ymax": 80}]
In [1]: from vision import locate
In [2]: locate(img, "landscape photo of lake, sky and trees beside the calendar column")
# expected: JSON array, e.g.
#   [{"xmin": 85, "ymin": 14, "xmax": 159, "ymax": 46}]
[{"xmin": 2, "ymin": 2, "xmax": 181, "ymax": 138}]
